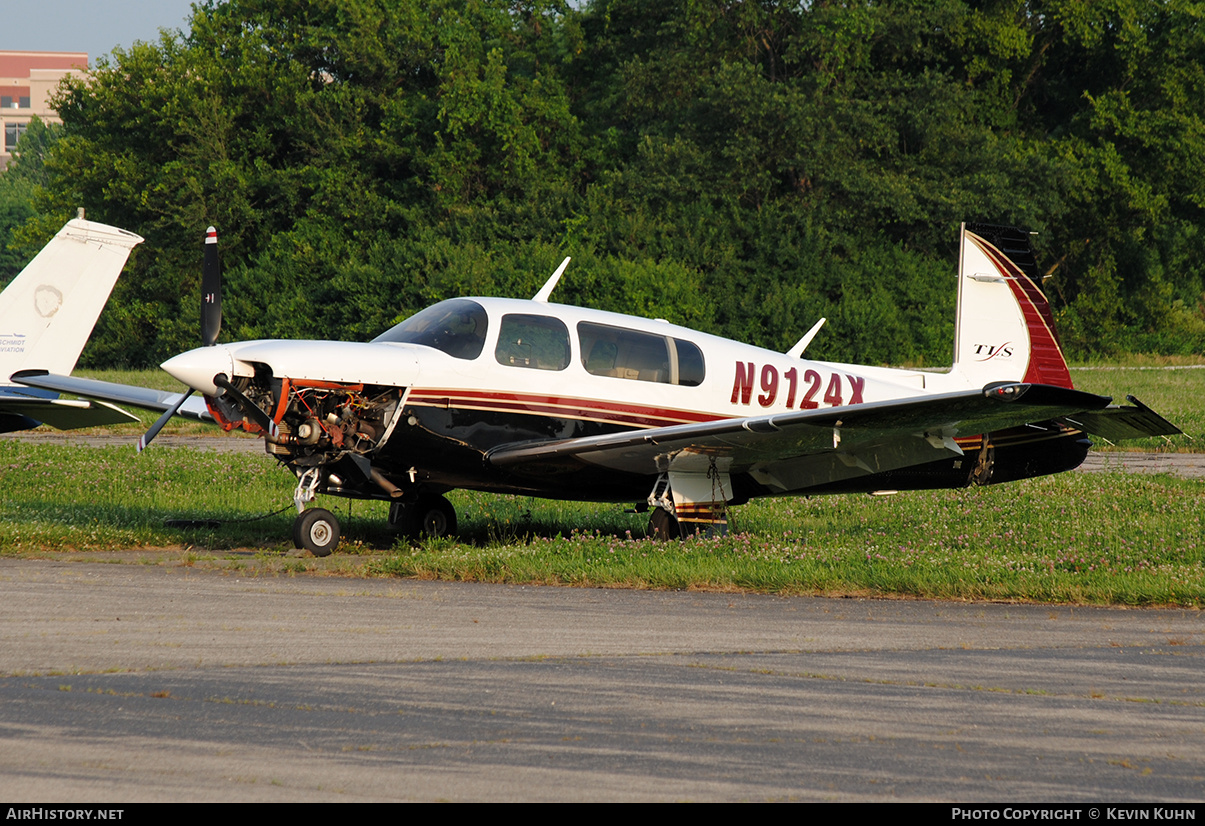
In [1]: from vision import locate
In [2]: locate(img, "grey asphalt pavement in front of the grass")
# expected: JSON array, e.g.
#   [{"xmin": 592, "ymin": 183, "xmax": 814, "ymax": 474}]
[{"xmin": 0, "ymin": 560, "xmax": 1205, "ymax": 800}]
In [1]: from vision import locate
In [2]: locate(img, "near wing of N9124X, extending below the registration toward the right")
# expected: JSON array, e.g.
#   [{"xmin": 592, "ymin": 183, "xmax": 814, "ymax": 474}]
[{"xmin": 487, "ymin": 383, "xmax": 1178, "ymax": 490}]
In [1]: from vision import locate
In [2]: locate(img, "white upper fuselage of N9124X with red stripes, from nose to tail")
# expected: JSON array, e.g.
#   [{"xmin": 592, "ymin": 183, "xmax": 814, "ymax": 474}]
[{"xmin": 163, "ymin": 298, "xmax": 968, "ymax": 428}]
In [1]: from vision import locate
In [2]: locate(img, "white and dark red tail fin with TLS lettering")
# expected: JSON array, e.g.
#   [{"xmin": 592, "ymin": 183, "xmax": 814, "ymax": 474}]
[{"xmin": 951, "ymin": 219, "xmax": 1071, "ymax": 387}]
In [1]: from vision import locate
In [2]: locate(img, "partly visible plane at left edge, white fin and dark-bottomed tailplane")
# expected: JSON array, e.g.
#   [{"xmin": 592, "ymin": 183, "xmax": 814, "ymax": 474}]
[{"xmin": 0, "ymin": 218, "xmax": 142, "ymax": 433}]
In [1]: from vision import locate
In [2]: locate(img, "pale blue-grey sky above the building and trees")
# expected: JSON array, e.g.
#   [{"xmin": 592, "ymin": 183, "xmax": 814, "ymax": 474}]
[{"xmin": 0, "ymin": 0, "xmax": 192, "ymax": 63}]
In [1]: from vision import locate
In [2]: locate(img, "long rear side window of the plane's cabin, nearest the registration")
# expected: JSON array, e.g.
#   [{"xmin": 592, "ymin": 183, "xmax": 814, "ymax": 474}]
[{"xmin": 577, "ymin": 321, "xmax": 704, "ymax": 387}]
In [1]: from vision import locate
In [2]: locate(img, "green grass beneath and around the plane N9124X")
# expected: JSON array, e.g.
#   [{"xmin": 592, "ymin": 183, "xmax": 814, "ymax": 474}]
[{"xmin": 0, "ymin": 356, "xmax": 1205, "ymax": 608}]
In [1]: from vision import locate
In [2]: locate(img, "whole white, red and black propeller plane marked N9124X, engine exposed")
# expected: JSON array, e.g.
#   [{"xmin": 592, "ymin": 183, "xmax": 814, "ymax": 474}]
[{"xmin": 13, "ymin": 224, "xmax": 1180, "ymax": 556}]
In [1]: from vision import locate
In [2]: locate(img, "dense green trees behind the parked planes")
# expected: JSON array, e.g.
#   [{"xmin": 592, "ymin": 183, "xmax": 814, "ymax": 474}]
[{"xmin": 0, "ymin": 0, "xmax": 1205, "ymax": 365}]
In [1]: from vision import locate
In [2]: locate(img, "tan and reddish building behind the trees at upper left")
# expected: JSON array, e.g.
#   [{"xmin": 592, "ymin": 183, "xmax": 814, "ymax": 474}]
[{"xmin": 0, "ymin": 52, "xmax": 88, "ymax": 169}]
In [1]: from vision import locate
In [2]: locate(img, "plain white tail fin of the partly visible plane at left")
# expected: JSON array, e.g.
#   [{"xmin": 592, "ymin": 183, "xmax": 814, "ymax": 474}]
[{"xmin": 0, "ymin": 218, "xmax": 142, "ymax": 385}]
